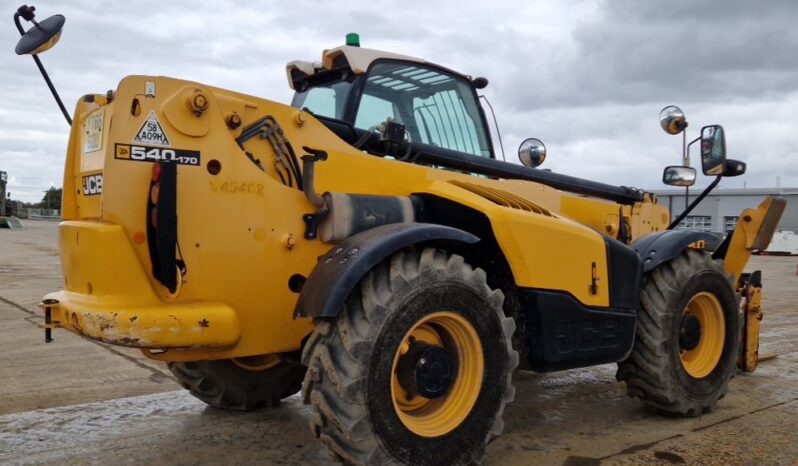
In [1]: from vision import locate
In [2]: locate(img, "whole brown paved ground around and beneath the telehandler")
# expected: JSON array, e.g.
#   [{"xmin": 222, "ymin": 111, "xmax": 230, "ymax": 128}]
[{"xmin": 0, "ymin": 222, "xmax": 798, "ymax": 466}]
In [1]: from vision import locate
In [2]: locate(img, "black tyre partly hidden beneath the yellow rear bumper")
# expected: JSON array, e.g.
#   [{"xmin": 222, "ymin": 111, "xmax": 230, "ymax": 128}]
[{"xmin": 168, "ymin": 359, "xmax": 306, "ymax": 411}]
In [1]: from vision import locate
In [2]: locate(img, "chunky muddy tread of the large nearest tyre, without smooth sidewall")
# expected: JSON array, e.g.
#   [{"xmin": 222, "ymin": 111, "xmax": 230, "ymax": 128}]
[{"xmin": 302, "ymin": 248, "xmax": 518, "ymax": 465}]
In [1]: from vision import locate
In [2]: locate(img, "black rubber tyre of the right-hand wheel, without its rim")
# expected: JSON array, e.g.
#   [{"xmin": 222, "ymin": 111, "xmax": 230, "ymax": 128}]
[{"xmin": 616, "ymin": 249, "xmax": 740, "ymax": 417}]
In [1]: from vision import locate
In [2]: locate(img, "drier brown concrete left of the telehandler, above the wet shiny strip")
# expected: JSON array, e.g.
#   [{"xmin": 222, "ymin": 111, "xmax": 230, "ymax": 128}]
[{"xmin": 0, "ymin": 220, "xmax": 180, "ymax": 414}]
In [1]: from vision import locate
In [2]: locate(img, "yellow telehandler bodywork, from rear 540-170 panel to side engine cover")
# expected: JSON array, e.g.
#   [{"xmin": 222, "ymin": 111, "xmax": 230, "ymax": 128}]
[{"xmin": 47, "ymin": 76, "xmax": 667, "ymax": 361}]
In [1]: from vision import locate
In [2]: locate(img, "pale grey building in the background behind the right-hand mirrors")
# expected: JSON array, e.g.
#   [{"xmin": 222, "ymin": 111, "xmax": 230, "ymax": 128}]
[{"xmin": 653, "ymin": 188, "xmax": 798, "ymax": 233}]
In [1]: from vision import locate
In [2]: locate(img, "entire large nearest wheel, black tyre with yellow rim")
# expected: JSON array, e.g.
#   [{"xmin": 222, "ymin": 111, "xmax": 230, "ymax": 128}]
[{"xmin": 302, "ymin": 249, "xmax": 518, "ymax": 466}]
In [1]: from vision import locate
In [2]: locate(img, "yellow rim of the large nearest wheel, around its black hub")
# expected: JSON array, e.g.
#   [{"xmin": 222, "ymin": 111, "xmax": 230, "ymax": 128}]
[{"xmin": 391, "ymin": 311, "xmax": 485, "ymax": 437}]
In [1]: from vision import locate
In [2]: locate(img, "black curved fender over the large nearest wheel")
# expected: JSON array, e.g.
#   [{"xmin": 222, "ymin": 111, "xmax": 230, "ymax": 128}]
[{"xmin": 294, "ymin": 223, "xmax": 479, "ymax": 317}]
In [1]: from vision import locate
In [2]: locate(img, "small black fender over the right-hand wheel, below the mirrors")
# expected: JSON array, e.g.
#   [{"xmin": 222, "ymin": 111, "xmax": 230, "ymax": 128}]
[{"xmin": 631, "ymin": 230, "xmax": 719, "ymax": 273}]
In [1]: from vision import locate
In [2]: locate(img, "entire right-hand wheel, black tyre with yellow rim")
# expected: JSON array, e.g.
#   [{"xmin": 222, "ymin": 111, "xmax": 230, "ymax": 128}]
[{"xmin": 616, "ymin": 249, "xmax": 739, "ymax": 417}]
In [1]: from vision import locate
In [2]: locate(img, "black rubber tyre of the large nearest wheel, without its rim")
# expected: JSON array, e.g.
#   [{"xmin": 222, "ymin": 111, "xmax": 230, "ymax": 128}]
[{"xmin": 302, "ymin": 248, "xmax": 518, "ymax": 466}]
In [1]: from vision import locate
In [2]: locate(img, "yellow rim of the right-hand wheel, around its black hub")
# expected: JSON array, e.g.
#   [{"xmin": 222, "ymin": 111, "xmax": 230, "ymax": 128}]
[{"xmin": 680, "ymin": 291, "xmax": 726, "ymax": 379}]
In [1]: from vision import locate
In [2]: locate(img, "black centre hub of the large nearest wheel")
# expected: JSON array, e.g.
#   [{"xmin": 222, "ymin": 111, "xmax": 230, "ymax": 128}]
[{"xmin": 398, "ymin": 341, "xmax": 457, "ymax": 399}]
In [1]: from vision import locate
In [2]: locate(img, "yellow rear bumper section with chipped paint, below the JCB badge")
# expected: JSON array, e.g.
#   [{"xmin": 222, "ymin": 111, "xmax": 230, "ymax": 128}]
[{"xmin": 44, "ymin": 221, "xmax": 241, "ymax": 348}]
